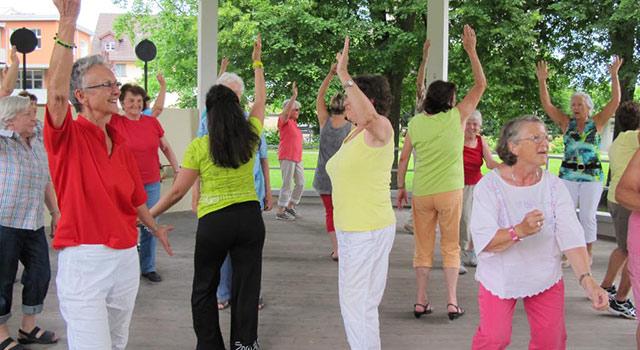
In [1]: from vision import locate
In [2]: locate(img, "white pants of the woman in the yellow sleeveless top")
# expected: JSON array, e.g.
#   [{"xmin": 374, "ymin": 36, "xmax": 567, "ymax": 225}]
[{"xmin": 336, "ymin": 223, "xmax": 396, "ymax": 350}]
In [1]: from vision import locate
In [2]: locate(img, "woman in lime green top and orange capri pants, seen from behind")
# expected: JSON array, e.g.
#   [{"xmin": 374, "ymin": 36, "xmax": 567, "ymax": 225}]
[{"xmin": 397, "ymin": 25, "xmax": 487, "ymax": 320}]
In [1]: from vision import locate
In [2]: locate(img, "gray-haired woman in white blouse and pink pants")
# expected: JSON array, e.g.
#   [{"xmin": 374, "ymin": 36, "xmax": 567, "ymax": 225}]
[{"xmin": 471, "ymin": 116, "xmax": 608, "ymax": 349}]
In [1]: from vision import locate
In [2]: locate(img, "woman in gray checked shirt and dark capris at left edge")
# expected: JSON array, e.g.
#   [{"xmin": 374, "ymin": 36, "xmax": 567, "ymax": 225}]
[{"xmin": 0, "ymin": 96, "xmax": 60, "ymax": 350}]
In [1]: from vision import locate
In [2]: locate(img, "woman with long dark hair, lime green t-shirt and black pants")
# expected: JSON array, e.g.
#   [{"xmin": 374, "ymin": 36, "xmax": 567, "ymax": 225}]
[{"xmin": 151, "ymin": 35, "xmax": 266, "ymax": 350}]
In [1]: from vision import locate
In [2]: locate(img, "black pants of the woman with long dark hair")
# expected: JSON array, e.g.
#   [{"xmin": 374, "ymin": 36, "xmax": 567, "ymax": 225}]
[{"xmin": 191, "ymin": 202, "xmax": 265, "ymax": 350}]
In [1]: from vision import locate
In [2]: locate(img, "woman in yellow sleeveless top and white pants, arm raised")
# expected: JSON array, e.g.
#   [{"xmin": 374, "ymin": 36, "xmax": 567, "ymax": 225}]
[{"xmin": 326, "ymin": 37, "xmax": 396, "ymax": 350}]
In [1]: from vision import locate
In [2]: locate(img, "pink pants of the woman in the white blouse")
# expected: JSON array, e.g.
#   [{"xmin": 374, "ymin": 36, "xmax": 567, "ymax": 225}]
[{"xmin": 471, "ymin": 280, "xmax": 567, "ymax": 350}]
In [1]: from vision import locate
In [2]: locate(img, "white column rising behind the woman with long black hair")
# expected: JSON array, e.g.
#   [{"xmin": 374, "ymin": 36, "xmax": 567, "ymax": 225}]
[{"xmin": 197, "ymin": 0, "xmax": 218, "ymax": 112}]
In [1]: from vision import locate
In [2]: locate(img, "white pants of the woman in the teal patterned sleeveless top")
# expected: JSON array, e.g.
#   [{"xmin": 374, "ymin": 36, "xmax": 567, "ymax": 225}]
[{"xmin": 562, "ymin": 180, "xmax": 603, "ymax": 243}]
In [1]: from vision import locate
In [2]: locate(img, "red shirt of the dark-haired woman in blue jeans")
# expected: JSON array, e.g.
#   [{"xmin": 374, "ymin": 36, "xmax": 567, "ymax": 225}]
[{"xmin": 109, "ymin": 114, "xmax": 164, "ymax": 185}]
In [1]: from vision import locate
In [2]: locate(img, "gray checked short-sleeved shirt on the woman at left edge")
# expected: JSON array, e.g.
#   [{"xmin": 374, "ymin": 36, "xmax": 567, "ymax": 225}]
[{"xmin": 0, "ymin": 121, "xmax": 51, "ymax": 230}]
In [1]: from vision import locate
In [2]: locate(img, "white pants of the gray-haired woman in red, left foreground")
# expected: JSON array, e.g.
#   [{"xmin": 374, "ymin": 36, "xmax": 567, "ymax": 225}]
[{"xmin": 56, "ymin": 244, "xmax": 140, "ymax": 350}]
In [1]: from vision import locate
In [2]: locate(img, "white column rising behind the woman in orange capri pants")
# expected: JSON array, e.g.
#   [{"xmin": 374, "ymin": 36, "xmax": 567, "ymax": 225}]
[{"xmin": 426, "ymin": 0, "xmax": 449, "ymax": 86}]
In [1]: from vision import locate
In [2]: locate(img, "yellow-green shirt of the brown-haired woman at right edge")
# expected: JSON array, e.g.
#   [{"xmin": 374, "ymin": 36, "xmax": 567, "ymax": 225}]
[{"xmin": 607, "ymin": 130, "xmax": 640, "ymax": 203}]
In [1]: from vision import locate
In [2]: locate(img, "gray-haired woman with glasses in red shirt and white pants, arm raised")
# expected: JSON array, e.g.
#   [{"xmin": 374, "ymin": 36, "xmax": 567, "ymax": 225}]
[{"xmin": 44, "ymin": 0, "xmax": 172, "ymax": 350}]
